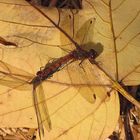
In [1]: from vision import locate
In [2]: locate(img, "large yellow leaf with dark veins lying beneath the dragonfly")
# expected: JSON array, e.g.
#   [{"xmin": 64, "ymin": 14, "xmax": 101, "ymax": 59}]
[{"xmin": 0, "ymin": 0, "xmax": 140, "ymax": 140}]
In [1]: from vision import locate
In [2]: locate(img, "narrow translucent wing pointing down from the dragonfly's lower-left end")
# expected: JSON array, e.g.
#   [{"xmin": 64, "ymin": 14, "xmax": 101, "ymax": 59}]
[{"xmin": 36, "ymin": 84, "xmax": 51, "ymax": 131}]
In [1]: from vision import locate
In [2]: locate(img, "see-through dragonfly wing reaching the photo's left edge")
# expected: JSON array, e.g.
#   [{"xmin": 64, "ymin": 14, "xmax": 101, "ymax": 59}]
[{"xmin": 0, "ymin": 61, "xmax": 33, "ymax": 90}]
